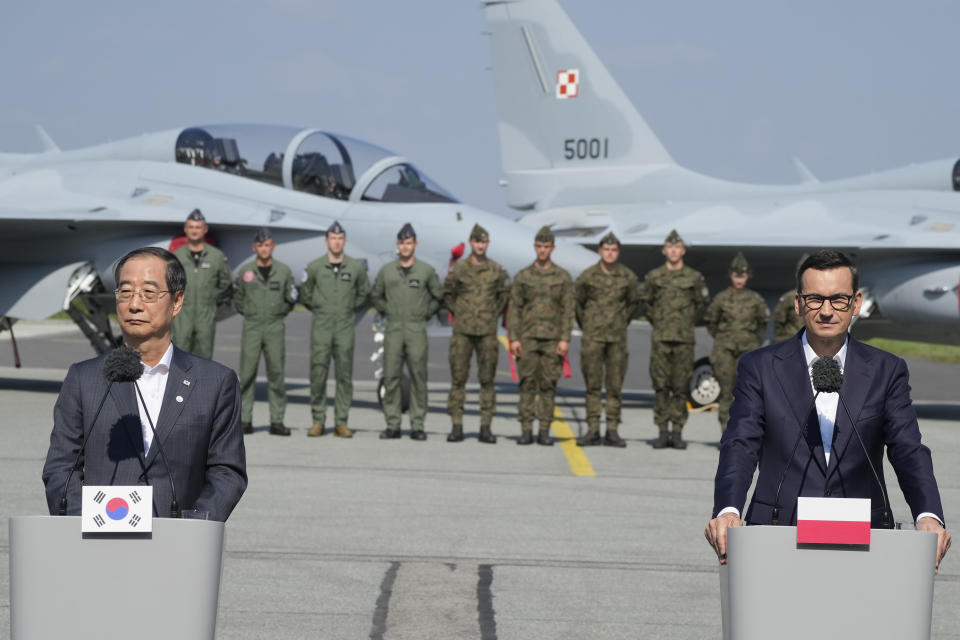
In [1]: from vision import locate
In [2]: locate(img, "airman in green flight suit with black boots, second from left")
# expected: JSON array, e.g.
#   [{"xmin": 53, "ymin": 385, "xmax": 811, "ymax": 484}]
[{"xmin": 233, "ymin": 228, "xmax": 297, "ymax": 436}]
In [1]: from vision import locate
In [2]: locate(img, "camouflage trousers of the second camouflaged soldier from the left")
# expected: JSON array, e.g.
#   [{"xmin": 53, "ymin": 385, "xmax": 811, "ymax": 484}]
[{"xmin": 517, "ymin": 338, "xmax": 563, "ymax": 430}]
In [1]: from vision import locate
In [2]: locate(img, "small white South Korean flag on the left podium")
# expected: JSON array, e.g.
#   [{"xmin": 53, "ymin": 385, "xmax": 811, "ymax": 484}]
[{"xmin": 80, "ymin": 485, "xmax": 153, "ymax": 533}]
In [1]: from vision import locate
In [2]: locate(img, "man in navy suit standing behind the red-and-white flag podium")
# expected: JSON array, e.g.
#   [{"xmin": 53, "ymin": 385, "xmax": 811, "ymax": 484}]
[{"xmin": 705, "ymin": 250, "xmax": 950, "ymax": 567}]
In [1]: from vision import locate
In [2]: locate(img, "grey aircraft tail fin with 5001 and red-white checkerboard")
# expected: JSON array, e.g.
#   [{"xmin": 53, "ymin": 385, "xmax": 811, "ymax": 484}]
[{"xmin": 485, "ymin": 0, "xmax": 674, "ymax": 180}]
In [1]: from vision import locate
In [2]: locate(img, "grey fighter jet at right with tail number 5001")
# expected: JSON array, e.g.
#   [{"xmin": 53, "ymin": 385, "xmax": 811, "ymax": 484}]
[{"xmin": 485, "ymin": 0, "xmax": 960, "ymax": 343}]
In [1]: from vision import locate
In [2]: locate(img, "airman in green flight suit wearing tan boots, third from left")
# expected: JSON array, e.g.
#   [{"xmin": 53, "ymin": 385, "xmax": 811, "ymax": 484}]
[{"xmin": 300, "ymin": 222, "xmax": 370, "ymax": 438}]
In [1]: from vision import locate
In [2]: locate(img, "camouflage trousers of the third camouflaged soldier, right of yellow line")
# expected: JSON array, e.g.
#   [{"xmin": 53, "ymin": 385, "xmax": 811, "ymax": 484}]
[{"xmin": 580, "ymin": 336, "xmax": 627, "ymax": 431}]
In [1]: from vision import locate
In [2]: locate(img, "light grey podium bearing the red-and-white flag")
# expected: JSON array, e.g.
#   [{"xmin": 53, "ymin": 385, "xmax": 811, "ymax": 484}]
[{"xmin": 720, "ymin": 526, "xmax": 937, "ymax": 640}]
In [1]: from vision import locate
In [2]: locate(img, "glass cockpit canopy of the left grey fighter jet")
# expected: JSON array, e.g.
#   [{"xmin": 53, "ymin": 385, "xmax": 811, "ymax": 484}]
[{"xmin": 176, "ymin": 125, "xmax": 457, "ymax": 203}]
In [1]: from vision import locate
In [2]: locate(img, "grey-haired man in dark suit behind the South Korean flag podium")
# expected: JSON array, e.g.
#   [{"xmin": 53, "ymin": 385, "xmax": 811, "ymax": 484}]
[{"xmin": 43, "ymin": 247, "xmax": 247, "ymax": 521}]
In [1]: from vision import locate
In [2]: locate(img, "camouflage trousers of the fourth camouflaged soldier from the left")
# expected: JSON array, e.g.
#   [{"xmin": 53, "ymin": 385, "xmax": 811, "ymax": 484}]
[{"xmin": 650, "ymin": 340, "xmax": 693, "ymax": 431}]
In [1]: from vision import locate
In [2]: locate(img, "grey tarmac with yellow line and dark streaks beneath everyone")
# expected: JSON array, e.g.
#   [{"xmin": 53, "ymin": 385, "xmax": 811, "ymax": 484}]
[{"xmin": 0, "ymin": 314, "xmax": 960, "ymax": 640}]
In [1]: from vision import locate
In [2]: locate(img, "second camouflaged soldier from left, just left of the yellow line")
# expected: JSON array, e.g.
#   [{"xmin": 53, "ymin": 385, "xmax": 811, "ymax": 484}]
[{"xmin": 507, "ymin": 227, "xmax": 574, "ymax": 445}]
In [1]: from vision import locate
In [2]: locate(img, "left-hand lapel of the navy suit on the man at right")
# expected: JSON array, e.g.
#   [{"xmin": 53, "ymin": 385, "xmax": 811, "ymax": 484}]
[{"xmin": 773, "ymin": 334, "xmax": 827, "ymax": 474}]
